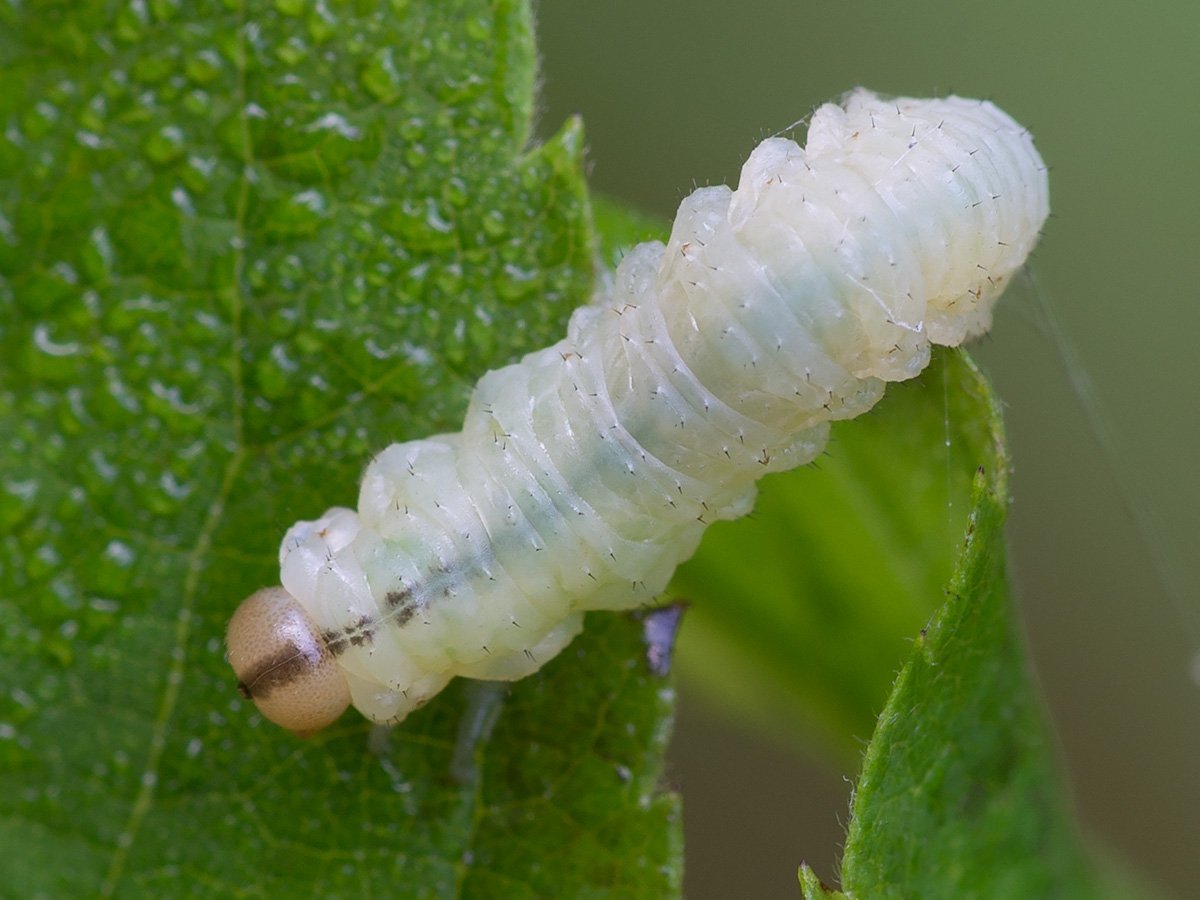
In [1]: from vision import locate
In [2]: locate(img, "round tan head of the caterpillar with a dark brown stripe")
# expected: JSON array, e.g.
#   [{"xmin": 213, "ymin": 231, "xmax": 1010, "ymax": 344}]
[{"xmin": 226, "ymin": 587, "xmax": 350, "ymax": 737}]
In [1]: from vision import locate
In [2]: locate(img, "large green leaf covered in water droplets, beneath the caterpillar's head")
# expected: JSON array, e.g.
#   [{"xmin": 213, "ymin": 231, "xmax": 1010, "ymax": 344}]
[{"xmin": 0, "ymin": 0, "xmax": 679, "ymax": 898}]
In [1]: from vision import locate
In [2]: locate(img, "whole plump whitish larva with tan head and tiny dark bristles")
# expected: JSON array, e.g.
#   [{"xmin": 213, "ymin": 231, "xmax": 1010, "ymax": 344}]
[{"xmin": 228, "ymin": 90, "xmax": 1049, "ymax": 733}]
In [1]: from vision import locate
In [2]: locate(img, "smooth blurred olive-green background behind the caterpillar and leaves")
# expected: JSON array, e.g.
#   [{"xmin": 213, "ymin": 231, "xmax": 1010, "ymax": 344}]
[{"xmin": 538, "ymin": 0, "xmax": 1200, "ymax": 900}]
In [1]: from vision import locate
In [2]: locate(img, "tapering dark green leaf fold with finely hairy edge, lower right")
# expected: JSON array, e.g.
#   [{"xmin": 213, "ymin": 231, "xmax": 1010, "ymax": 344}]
[{"xmin": 825, "ymin": 355, "xmax": 1130, "ymax": 898}]
